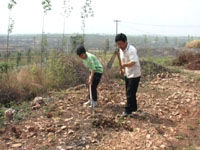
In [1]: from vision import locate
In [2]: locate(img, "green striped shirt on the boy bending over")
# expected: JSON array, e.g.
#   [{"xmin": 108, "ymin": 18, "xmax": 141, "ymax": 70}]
[{"xmin": 83, "ymin": 52, "xmax": 103, "ymax": 73}]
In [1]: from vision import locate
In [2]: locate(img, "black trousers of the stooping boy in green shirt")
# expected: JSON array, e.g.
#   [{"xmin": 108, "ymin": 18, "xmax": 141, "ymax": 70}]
[{"xmin": 91, "ymin": 72, "xmax": 102, "ymax": 101}]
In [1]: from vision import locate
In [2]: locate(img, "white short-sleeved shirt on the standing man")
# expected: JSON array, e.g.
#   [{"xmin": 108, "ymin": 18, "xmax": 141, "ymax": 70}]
[{"xmin": 120, "ymin": 44, "xmax": 141, "ymax": 78}]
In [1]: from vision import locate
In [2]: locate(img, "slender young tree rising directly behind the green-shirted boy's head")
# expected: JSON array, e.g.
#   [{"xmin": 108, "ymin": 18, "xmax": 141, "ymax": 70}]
[{"xmin": 81, "ymin": 0, "xmax": 94, "ymax": 45}]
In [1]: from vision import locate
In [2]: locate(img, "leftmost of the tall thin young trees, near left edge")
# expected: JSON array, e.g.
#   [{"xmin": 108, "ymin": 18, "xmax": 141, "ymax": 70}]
[{"xmin": 6, "ymin": 0, "xmax": 17, "ymax": 62}]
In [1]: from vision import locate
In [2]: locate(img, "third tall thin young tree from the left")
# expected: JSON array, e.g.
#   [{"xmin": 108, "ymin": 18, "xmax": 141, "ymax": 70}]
[{"xmin": 62, "ymin": 0, "xmax": 73, "ymax": 51}]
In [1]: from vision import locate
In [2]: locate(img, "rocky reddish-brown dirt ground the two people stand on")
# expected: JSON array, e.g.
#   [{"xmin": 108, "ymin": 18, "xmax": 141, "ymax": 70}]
[{"xmin": 0, "ymin": 74, "xmax": 200, "ymax": 150}]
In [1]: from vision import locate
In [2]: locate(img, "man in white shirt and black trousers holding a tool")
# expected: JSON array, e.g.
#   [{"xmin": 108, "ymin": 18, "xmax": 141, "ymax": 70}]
[{"xmin": 115, "ymin": 33, "xmax": 141, "ymax": 116}]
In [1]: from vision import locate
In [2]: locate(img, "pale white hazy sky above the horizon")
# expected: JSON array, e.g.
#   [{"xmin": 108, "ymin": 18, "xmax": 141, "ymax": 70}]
[{"xmin": 0, "ymin": 0, "xmax": 200, "ymax": 36}]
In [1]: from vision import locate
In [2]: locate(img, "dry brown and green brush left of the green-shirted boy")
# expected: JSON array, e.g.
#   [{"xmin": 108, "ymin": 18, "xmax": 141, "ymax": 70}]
[{"xmin": 0, "ymin": 52, "xmax": 89, "ymax": 104}]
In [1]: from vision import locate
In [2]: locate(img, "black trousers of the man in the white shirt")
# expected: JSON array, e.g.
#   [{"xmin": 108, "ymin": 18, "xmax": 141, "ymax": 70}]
[{"xmin": 125, "ymin": 77, "xmax": 140, "ymax": 113}]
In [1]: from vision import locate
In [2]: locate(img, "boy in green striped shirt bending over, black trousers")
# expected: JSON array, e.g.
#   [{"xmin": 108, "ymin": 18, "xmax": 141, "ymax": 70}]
[{"xmin": 77, "ymin": 46, "xmax": 103, "ymax": 107}]
